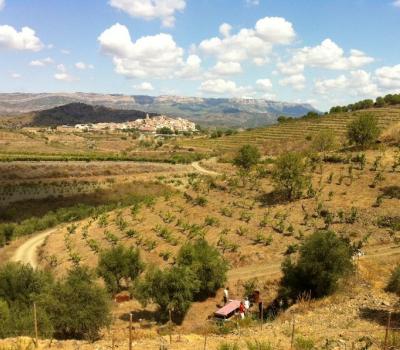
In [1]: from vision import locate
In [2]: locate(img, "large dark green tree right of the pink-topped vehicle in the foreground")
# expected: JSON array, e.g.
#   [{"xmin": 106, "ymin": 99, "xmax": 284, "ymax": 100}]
[{"xmin": 280, "ymin": 231, "xmax": 353, "ymax": 299}]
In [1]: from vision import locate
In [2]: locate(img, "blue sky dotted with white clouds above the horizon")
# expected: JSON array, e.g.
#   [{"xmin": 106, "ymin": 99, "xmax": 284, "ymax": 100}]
[{"xmin": 0, "ymin": 0, "xmax": 400, "ymax": 110}]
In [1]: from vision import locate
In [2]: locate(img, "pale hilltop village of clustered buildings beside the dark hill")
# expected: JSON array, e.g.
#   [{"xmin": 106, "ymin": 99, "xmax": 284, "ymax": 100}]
[{"xmin": 75, "ymin": 114, "xmax": 196, "ymax": 134}]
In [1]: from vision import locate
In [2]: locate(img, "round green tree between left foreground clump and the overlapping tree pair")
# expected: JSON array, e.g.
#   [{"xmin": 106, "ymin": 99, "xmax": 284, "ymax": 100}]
[{"xmin": 97, "ymin": 244, "xmax": 144, "ymax": 294}]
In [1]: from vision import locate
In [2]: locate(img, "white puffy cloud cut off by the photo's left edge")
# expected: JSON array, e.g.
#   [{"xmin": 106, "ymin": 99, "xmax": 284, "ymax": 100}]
[{"xmin": 0, "ymin": 25, "xmax": 44, "ymax": 51}]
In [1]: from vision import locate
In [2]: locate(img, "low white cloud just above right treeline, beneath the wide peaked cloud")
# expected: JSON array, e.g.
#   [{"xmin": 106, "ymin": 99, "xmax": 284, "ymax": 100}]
[{"xmin": 314, "ymin": 70, "xmax": 380, "ymax": 98}]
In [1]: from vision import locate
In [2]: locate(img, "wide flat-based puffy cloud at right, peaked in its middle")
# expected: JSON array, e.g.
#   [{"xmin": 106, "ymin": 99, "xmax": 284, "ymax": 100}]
[{"xmin": 290, "ymin": 39, "xmax": 374, "ymax": 70}]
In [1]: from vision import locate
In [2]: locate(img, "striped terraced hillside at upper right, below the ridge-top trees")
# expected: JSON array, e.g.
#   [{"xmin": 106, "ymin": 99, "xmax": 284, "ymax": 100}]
[{"xmin": 183, "ymin": 107, "xmax": 400, "ymax": 151}]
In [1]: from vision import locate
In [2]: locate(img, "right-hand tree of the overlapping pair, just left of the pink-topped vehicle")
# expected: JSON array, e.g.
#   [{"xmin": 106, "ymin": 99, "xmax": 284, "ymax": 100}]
[{"xmin": 177, "ymin": 239, "xmax": 228, "ymax": 300}]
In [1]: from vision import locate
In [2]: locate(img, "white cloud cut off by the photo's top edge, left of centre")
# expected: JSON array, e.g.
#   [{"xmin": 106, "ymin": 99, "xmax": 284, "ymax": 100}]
[{"xmin": 110, "ymin": 0, "xmax": 186, "ymax": 27}]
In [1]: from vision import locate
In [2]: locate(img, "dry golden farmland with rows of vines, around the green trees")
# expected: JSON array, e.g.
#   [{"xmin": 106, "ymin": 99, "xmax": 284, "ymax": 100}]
[{"xmin": 0, "ymin": 108, "xmax": 400, "ymax": 350}]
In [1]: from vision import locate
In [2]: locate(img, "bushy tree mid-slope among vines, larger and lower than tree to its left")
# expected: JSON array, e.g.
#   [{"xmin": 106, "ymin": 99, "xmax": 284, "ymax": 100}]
[{"xmin": 272, "ymin": 152, "xmax": 306, "ymax": 200}]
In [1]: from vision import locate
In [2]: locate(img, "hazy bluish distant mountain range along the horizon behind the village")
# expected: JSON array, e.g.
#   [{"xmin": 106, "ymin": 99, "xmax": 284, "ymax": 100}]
[{"xmin": 0, "ymin": 92, "xmax": 316, "ymax": 127}]
